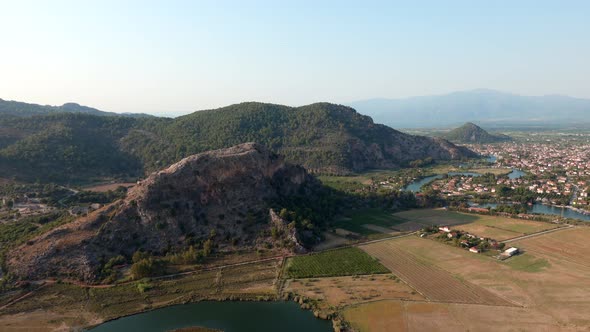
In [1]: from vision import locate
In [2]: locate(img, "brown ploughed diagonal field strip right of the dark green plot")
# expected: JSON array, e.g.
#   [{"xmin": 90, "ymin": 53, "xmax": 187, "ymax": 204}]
[{"xmin": 359, "ymin": 241, "xmax": 514, "ymax": 306}]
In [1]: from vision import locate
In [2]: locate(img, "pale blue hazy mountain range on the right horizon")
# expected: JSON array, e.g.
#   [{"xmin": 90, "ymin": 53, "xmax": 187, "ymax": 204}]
[{"xmin": 348, "ymin": 89, "xmax": 590, "ymax": 128}]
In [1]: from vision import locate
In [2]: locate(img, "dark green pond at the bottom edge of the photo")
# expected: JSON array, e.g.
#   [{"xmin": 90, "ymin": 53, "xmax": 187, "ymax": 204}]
[{"xmin": 90, "ymin": 301, "xmax": 333, "ymax": 332}]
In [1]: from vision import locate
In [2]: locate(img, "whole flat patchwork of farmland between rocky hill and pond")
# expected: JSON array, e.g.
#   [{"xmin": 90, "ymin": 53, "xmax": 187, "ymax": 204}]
[{"xmin": 0, "ymin": 210, "xmax": 590, "ymax": 332}]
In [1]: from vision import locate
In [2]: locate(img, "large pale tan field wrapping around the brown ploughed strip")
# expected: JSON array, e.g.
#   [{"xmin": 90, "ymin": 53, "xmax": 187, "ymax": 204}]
[{"xmin": 350, "ymin": 233, "xmax": 590, "ymax": 331}]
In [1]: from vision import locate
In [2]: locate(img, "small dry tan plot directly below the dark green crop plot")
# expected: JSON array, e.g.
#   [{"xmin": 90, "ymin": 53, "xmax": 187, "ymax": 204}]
[{"xmin": 284, "ymin": 274, "xmax": 426, "ymax": 307}]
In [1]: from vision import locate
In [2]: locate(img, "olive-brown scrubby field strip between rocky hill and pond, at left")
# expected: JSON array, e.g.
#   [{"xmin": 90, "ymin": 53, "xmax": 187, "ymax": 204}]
[{"xmin": 0, "ymin": 260, "xmax": 280, "ymax": 331}]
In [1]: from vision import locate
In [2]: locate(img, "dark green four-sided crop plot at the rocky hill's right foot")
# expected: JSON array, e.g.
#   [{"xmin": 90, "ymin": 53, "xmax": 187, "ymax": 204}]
[{"xmin": 284, "ymin": 247, "xmax": 389, "ymax": 278}]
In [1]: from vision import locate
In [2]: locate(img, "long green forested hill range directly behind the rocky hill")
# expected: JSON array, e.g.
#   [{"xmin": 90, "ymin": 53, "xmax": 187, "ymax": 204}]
[{"xmin": 0, "ymin": 103, "xmax": 475, "ymax": 181}]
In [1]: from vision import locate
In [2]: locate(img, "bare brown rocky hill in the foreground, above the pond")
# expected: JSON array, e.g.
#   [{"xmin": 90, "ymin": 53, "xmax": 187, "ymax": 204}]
[{"xmin": 6, "ymin": 143, "xmax": 322, "ymax": 282}]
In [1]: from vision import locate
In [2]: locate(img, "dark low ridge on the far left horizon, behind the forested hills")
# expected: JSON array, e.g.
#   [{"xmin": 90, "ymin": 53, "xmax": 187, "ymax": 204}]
[{"xmin": 0, "ymin": 99, "xmax": 151, "ymax": 117}]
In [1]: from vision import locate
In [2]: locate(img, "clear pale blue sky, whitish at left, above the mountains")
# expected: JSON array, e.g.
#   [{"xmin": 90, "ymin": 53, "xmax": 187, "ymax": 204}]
[{"xmin": 0, "ymin": 0, "xmax": 590, "ymax": 114}]
